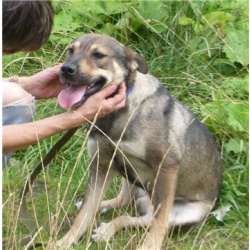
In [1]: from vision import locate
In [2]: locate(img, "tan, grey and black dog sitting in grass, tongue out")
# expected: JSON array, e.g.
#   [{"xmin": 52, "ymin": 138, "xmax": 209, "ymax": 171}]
[{"xmin": 55, "ymin": 34, "xmax": 222, "ymax": 250}]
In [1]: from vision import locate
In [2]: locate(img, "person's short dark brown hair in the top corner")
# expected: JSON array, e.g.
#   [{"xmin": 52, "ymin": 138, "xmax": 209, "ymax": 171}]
[{"xmin": 2, "ymin": 0, "xmax": 54, "ymax": 54}]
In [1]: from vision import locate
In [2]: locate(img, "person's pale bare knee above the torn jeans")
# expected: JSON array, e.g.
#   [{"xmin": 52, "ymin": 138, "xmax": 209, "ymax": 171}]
[{"xmin": 2, "ymin": 82, "xmax": 32, "ymax": 106}]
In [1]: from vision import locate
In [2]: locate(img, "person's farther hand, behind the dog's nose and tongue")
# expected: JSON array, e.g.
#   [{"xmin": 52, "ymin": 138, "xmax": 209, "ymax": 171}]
[{"xmin": 18, "ymin": 64, "xmax": 66, "ymax": 99}]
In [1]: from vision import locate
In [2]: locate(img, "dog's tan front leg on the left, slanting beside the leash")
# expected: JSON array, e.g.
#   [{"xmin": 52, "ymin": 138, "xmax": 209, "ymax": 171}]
[{"xmin": 56, "ymin": 168, "xmax": 116, "ymax": 249}]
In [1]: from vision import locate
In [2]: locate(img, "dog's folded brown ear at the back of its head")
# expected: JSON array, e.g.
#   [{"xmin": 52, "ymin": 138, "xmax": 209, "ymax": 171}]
[{"xmin": 125, "ymin": 47, "xmax": 148, "ymax": 74}]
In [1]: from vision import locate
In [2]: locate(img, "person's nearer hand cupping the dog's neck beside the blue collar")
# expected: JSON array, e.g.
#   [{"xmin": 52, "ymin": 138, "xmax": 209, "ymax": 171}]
[{"xmin": 75, "ymin": 82, "xmax": 126, "ymax": 121}]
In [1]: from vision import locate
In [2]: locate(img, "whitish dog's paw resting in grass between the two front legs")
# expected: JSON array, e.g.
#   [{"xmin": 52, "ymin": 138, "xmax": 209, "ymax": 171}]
[{"xmin": 91, "ymin": 222, "xmax": 116, "ymax": 242}]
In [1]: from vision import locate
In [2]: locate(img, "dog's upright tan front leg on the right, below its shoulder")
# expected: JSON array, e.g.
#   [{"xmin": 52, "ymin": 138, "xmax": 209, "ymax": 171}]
[{"xmin": 139, "ymin": 166, "xmax": 178, "ymax": 250}]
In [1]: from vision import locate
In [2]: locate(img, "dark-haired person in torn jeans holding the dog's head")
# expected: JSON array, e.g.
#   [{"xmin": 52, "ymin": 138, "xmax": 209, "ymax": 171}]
[{"xmin": 2, "ymin": 0, "xmax": 126, "ymax": 167}]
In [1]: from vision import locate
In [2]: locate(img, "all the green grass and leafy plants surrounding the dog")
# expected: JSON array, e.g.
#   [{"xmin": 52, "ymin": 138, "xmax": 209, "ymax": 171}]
[{"xmin": 3, "ymin": 1, "xmax": 249, "ymax": 249}]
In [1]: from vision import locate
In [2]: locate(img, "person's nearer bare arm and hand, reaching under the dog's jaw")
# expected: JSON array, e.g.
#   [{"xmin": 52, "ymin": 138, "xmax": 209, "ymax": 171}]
[{"xmin": 2, "ymin": 83, "xmax": 126, "ymax": 153}]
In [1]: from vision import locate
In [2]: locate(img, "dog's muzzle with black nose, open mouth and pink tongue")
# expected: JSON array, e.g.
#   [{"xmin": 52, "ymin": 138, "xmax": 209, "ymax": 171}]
[{"xmin": 58, "ymin": 63, "xmax": 107, "ymax": 109}]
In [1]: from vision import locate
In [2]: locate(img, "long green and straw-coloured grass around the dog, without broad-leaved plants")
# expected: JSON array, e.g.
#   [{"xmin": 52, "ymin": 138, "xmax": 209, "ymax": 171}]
[{"xmin": 2, "ymin": 1, "xmax": 249, "ymax": 250}]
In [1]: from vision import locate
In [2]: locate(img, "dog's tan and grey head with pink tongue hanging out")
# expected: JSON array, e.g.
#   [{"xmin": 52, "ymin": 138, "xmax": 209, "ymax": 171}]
[{"xmin": 58, "ymin": 34, "xmax": 148, "ymax": 109}]
